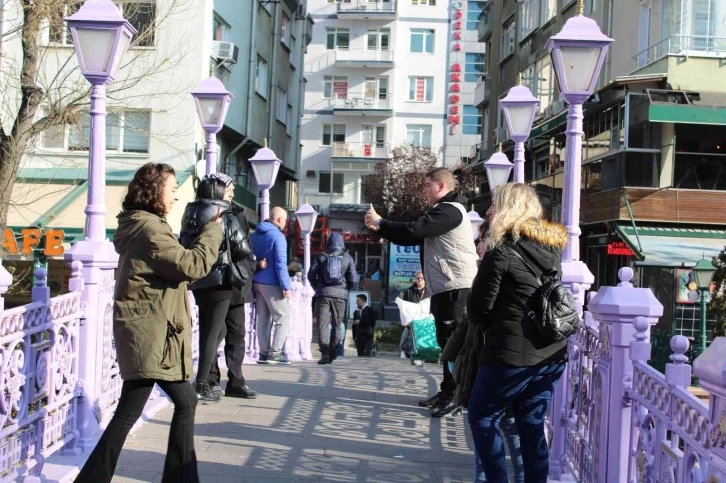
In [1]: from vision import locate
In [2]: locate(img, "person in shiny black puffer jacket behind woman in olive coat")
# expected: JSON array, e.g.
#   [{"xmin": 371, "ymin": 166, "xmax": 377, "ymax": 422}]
[{"xmin": 179, "ymin": 173, "xmax": 257, "ymax": 403}]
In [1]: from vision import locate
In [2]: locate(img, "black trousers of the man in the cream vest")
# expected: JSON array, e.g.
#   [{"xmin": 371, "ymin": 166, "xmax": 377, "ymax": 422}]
[{"xmin": 431, "ymin": 288, "xmax": 470, "ymax": 397}]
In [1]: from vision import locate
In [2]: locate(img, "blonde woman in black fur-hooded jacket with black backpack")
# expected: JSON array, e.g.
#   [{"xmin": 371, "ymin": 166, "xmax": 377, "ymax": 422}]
[{"xmin": 467, "ymin": 183, "xmax": 567, "ymax": 483}]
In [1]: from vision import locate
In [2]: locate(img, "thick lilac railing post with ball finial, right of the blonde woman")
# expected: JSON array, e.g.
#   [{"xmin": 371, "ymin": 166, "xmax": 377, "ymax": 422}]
[{"xmin": 589, "ymin": 267, "xmax": 663, "ymax": 483}]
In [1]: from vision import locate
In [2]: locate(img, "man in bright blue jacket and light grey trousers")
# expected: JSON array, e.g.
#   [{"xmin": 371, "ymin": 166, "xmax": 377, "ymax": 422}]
[{"xmin": 252, "ymin": 206, "xmax": 292, "ymax": 365}]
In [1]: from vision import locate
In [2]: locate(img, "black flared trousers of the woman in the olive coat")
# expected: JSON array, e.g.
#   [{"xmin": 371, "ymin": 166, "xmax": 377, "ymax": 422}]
[{"xmin": 75, "ymin": 379, "xmax": 199, "ymax": 483}]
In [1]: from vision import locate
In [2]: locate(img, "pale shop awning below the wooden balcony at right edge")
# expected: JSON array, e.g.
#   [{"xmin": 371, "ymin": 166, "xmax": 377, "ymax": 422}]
[{"xmin": 615, "ymin": 223, "xmax": 726, "ymax": 267}]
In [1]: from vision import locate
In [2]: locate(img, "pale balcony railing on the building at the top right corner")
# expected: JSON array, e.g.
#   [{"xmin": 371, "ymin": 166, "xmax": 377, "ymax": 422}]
[{"xmin": 633, "ymin": 35, "xmax": 726, "ymax": 70}]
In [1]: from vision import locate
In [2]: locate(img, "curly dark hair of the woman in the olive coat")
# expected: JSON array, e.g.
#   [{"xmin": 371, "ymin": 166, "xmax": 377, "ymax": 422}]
[{"xmin": 121, "ymin": 163, "xmax": 176, "ymax": 216}]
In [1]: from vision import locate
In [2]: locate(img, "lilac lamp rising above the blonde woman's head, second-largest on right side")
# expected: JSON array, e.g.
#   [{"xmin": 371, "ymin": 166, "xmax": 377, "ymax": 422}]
[{"xmin": 499, "ymin": 80, "xmax": 539, "ymax": 183}]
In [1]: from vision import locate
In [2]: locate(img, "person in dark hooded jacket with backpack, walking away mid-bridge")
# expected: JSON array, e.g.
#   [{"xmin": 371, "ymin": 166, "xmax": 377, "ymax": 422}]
[{"xmin": 308, "ymin": 233, "xmax": 358, "ymax": 364}]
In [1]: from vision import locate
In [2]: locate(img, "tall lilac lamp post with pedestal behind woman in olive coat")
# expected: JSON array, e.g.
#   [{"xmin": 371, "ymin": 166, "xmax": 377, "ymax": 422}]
[{"xmin": 65, "ymin": 0, "xmax": 136, "ymax": 450}]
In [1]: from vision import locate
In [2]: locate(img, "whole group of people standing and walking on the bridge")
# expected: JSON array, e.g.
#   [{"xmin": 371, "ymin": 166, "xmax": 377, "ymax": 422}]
[{"xmin": 76, "ymin": 163, "xmax": 567, "ymax": 483}]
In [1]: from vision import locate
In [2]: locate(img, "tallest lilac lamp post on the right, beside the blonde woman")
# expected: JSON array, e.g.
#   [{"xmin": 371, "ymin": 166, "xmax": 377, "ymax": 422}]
[{"xmin": 547, "ymin": 0, "xmax": 613, "ymax": 477}]
